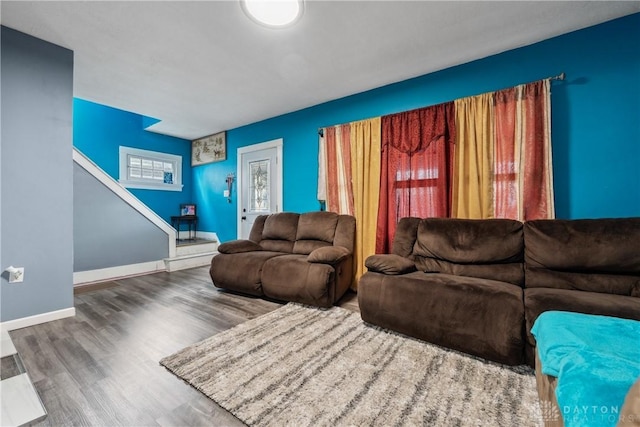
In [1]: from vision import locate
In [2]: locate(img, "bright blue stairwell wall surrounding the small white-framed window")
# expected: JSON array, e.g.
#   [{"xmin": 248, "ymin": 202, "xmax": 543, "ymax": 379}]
[{"xmin": 73, "ymin": 98, "xmax": 193, "ymax": 222}]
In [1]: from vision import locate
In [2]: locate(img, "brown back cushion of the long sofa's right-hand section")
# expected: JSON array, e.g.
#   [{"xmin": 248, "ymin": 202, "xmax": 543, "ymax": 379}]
[{"xmin": 524, "ymin": 218, "xmax": 640, "ymax": 295}]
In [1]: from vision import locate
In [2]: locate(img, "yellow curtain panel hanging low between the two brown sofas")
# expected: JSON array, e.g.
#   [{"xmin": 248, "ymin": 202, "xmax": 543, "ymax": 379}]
[{"xmin": 351, "ymin": 117, "xmax": 381, "ymax": 290}]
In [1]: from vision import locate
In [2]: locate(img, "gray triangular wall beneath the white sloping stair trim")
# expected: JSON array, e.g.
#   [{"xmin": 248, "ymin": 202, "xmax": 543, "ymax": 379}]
[{"xmin": 73, "ymin": 164, "xmax": 169, "ymax": 272}]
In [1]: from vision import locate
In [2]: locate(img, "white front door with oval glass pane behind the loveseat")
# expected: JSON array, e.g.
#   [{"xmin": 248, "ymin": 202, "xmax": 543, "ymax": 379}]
[{"xmin": 238, "ymin": 139, "xmax": 283, "ymax": 239}]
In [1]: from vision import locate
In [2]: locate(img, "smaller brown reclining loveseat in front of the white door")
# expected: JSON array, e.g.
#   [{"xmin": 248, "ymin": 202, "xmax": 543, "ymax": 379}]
[{"xmin": 209, "ymin": 212, "xmax": 355, "ymax": 307}]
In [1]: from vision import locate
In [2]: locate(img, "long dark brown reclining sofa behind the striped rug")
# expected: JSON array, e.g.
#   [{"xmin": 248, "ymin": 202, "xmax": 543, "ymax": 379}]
[{"xmin": 358, "ymin": 218, "xmax": 640, "ymax": 366}]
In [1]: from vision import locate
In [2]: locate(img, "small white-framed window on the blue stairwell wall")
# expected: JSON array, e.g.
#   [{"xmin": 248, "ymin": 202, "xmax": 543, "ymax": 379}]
[{"xmin": 119, "ymin": 146, "xmax": 182, "ymax": 191}]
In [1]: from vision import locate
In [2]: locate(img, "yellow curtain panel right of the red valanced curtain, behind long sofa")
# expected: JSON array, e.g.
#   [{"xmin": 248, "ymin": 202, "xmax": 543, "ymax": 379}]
[{"xmin": 451, "ymin": 93, "xmax": 494, "ymax": 219}]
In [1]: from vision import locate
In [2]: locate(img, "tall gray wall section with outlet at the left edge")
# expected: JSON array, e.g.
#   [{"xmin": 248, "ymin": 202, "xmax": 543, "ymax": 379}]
[{"xmin": 0, "ymin": 27, "xmax": 73, "ymax": 321}]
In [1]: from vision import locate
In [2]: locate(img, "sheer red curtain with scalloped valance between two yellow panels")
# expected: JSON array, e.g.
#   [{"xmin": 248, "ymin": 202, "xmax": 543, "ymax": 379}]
[{"xmin": 376, "ymin": 102, "xmax": 455, "ymax": 253}]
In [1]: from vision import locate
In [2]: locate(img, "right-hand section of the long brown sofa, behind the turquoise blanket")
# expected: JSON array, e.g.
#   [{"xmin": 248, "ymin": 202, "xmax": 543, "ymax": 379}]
[{"xmin": 524, "ymin": 218, "xmax": 640, "ymax": 364}]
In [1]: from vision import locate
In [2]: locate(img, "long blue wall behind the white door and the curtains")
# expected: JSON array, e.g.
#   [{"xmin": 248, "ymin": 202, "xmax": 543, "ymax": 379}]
[{"xmin": 193, "ymin": 14, "xmax": 640, "ymax": 241}]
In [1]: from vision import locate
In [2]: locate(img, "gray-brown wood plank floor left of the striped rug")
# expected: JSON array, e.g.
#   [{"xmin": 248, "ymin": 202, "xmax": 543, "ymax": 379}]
[{"xmin": 11, "ymin": 267, "xmax": 358, "ymax": 426}]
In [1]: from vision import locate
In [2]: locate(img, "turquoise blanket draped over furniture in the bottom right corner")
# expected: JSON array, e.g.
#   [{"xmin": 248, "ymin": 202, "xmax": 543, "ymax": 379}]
[{"xmin": 531, "ymin": 311, "xmax": 640, "ymax": 427}]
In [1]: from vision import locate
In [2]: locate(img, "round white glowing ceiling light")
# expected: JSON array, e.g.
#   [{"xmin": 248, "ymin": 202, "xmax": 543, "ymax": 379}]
[{"xmin": 240, "ymin": 0, "xmax": 304, "ymax": 28}]
